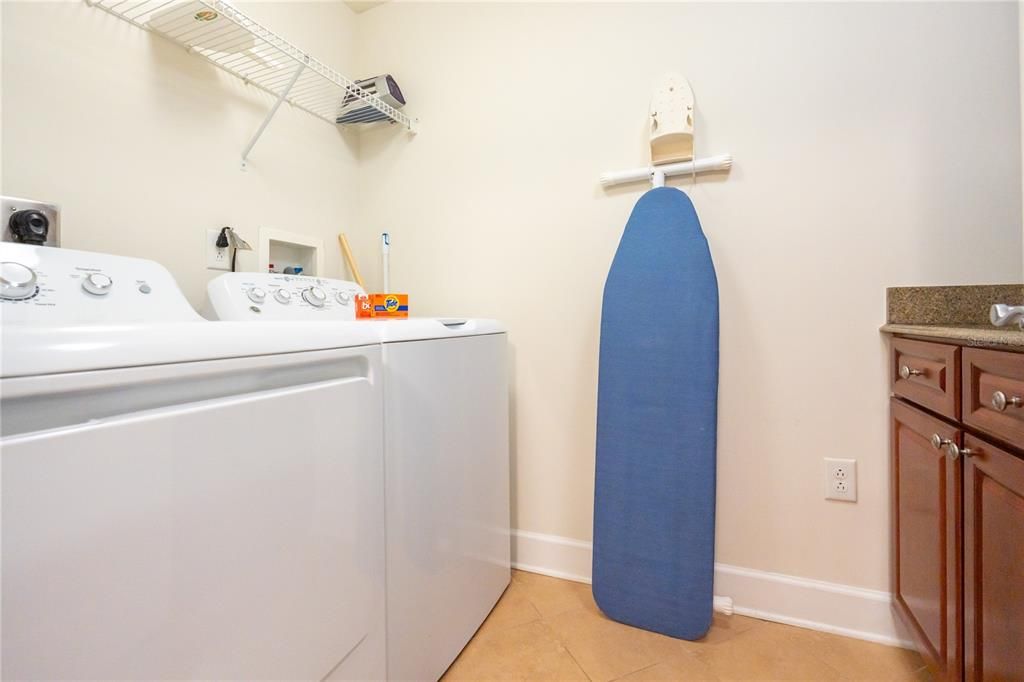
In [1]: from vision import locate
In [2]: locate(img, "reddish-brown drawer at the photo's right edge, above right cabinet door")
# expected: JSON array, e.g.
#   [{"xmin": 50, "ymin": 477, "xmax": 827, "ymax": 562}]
[{"xmin": 964, "ymin": 348, "xmax": 1024, "ymax": 447}]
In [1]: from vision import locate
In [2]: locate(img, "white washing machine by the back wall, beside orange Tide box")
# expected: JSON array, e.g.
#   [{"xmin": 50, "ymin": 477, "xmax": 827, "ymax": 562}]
[{"xmin": 209, "ymin": 272, "xmax": 510, "ymax": 680}]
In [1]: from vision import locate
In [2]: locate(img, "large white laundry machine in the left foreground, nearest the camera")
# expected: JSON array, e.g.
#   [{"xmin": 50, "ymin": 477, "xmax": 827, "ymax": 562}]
[{"xmin": 0, "ymin": 244, "xmax": 386, "ymax": 679}]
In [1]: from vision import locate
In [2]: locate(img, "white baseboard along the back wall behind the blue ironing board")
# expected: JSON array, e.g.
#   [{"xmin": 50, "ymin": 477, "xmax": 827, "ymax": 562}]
[{"xmin": 512, "ymin": 530, "xmax": 911, "ymax": 647}]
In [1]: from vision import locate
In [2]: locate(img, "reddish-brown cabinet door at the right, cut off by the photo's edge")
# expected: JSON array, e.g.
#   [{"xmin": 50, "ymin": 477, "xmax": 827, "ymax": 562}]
[{"xmin": 963, "ymin": 436, "xmax": 1024, "ymax": 680}]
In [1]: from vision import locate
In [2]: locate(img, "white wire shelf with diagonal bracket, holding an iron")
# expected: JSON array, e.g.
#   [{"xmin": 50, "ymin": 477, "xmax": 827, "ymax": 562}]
[{"xmin": 86, "ymin": 0, "xmax": 416, "ymax": 160}]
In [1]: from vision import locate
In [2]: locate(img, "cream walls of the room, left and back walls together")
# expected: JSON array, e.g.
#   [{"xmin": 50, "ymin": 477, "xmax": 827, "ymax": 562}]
[{"xmin": 0, "ymin": 1, "xmax": 1022, "ymax": 588}]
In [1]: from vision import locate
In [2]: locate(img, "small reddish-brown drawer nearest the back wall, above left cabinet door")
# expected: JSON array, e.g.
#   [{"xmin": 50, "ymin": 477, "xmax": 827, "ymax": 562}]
[{"xmin": 889, "ymin": 339, "xmax": 961, "ymax": 419}]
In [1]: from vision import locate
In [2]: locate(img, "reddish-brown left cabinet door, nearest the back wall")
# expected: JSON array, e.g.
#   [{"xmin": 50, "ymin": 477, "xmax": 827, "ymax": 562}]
[{"xmin": 891, "ymin": 398, "xmax": 963, "ymax": 680}]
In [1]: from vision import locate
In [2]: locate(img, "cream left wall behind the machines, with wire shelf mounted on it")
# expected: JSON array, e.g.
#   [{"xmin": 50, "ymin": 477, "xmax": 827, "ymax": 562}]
[{"xmin": 0, "ymin": 0, "xmax": 358, "ymax": 305}]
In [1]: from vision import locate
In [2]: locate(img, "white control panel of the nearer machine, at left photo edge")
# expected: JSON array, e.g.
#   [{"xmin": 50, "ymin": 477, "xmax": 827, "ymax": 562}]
[{"xmin": 0, "ymin": 242, "xmax": 201, "ymax": 324}]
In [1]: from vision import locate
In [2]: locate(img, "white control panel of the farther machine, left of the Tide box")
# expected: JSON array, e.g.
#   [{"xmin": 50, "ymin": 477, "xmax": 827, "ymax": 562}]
[{"xmin": 204, "ymin": 272, "xmax": 366, "ymax": 321}]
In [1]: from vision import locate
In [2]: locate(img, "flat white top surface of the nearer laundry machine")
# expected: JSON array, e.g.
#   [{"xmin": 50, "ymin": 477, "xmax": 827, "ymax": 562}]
[{"xmin": 0, "ymin": 321, "xmax": 380, "ymax": 377}]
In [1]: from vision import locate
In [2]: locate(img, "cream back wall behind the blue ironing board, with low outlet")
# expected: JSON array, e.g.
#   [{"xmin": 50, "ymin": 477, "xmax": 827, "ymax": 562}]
[{"xmin": 356, "ymin": 3, "xmax": 1022, "ymax": 589}]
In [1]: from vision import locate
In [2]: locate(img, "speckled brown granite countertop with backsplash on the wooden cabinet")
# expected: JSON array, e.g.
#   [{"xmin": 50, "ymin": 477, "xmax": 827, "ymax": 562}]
[{"xmin": 882, "ymin": 285, "xmax": 1024, "ymax": 348}]
